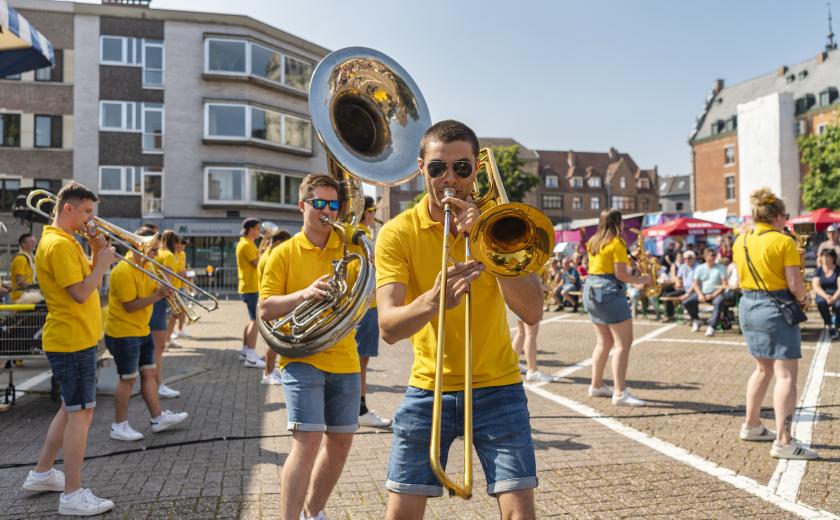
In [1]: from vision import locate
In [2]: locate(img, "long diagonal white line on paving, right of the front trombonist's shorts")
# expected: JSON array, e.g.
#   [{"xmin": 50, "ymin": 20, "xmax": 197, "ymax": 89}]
[{"xmin": 525, "ymin": 384, "xmax": 838, "ymax": 519}]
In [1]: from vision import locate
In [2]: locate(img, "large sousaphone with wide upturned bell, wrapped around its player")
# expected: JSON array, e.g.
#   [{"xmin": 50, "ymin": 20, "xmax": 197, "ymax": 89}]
[{"xmin": 257, "ymin": 47, "xmax": 431, "ymax": 357}]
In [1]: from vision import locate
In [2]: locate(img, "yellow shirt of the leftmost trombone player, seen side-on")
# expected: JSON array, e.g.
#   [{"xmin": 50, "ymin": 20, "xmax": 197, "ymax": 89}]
[{"xmin": 35, "ymin": 226, "xmax": 102, "ymax": 352}]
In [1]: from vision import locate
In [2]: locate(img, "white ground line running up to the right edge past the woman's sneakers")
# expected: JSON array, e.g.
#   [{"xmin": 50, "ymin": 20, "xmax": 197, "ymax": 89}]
[{"xmin": 767, "ymin": 330, "xmax": 831, "ymax": 500}]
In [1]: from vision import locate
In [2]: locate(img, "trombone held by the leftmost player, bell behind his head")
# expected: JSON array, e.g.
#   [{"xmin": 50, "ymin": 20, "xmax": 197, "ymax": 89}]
[{"xmin": 26, "ymin": 190, "xmax": 219, "ymax": 314}]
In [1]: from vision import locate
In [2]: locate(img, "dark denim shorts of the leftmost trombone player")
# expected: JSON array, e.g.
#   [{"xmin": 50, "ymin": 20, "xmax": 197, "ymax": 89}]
[{"xmin": 46, "ymin": 346, "xmax": 96, "ymax": 412}]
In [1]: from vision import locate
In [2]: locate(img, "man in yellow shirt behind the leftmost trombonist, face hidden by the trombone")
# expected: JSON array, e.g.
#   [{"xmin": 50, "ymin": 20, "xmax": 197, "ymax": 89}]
[{"xmin": 105, "ymin": 228, "xmax": 187, "ymax": 441}]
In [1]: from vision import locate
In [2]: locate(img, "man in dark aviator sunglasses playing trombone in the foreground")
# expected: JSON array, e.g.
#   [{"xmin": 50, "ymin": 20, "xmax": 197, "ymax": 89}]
[{"xmin": 376, "ymin": 120, "xmax": 543, "ymax": 520}]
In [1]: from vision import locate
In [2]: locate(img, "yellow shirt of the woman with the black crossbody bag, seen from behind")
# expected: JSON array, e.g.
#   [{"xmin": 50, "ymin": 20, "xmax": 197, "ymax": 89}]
[{"xmin": 732, "ymin": 222, "xmax": 800, "ymax": 291}]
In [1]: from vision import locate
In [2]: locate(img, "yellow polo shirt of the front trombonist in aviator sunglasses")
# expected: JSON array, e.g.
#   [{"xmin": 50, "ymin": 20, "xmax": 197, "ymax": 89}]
[{"xmin": 376, "ymin": 194, "xmax": 522, "ymax": 391}]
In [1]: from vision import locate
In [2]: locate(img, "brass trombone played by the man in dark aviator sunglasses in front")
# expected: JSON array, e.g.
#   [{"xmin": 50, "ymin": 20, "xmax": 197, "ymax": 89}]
[{"xmin": 429, "ymin": 148, "xmax": 554, "ymax": 499}]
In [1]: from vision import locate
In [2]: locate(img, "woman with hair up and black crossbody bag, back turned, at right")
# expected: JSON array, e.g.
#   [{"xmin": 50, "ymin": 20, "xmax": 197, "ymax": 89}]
[{"xmin": 732, "ymin": 188, "xmax": 819, "ymax": 460}]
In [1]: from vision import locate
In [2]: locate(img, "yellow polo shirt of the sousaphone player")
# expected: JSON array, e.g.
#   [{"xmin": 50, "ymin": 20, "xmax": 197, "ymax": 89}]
[{"xmin": 258, "ymin": 230, "xmax": 360, "ymax": 374}]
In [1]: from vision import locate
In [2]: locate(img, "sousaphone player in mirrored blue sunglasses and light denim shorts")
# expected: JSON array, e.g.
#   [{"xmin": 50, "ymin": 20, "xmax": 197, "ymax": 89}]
[{"xmin": 260, "ymin": 175, "xmax": 359, "ymax": 520}]
